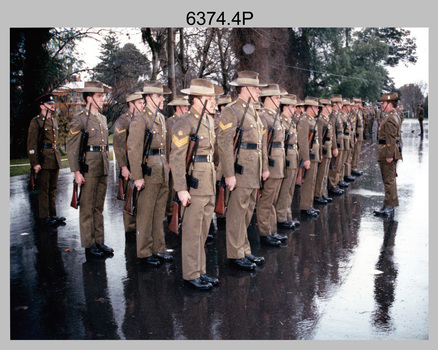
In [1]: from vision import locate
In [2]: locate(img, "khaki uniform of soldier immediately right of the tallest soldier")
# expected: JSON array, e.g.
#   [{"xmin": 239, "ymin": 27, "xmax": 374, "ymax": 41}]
[{"xmin": 256, "ymin": 108, "xmax": 286, "ymax": 236}]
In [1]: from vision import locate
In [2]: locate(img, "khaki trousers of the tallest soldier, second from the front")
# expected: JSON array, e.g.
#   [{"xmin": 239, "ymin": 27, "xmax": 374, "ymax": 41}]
[{"xmin": 225, "ymin": 186, "xmax": 257, "ymax": 259}]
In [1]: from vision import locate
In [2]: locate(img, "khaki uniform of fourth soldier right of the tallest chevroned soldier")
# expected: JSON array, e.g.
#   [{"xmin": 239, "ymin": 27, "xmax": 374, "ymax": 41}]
[{"xmin": 315, "ymin": 113, "xmax": 336, "ymax": 198}]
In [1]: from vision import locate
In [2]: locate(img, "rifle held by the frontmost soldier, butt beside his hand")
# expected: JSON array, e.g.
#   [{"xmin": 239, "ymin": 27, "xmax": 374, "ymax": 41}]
[{"xmin": 168, "ymin": 101, "xmax": 207, "ymax": 235}]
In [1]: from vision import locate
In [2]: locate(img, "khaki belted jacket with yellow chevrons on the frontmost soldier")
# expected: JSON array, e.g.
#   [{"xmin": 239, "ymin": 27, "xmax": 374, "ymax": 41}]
[{"xmin": 169, "ymin": 107, "xmax": 216, "ymax": 196}]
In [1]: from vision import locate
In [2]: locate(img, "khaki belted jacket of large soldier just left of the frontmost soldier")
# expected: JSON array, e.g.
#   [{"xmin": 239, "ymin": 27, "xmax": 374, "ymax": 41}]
[{"xmin": 128, "ymin": 106, "xmax": 169, "ymax": 184}]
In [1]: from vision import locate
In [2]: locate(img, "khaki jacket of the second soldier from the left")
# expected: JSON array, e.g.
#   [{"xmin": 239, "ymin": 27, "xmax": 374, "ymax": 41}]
[{"xmin": 67, "ymin": 109, "xmax": 109, "ymax": 176}]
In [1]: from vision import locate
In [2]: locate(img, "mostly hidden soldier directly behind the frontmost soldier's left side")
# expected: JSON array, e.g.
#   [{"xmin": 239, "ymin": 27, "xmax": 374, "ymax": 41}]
[{"xmin": 166, "ymin": 95, "xmax": 190, "ymax": 218}]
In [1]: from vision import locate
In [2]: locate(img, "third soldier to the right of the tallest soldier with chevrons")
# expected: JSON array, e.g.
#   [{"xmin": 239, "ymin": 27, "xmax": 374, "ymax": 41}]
[{"xmin": 297, "ymin": 96, "xmax": 320, "ymax": 218}]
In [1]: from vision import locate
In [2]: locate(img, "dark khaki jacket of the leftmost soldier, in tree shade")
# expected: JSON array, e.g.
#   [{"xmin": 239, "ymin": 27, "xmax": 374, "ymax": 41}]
[{"xmin": 27, "ymin": 114, "xmax": 62, "ymax": 169}]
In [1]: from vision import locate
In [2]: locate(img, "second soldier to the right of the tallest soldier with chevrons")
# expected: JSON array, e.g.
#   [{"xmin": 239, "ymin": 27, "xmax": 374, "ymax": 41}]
[{"xmin": 275, "ymin": 94, "xmax": 300, "ymax": 229}]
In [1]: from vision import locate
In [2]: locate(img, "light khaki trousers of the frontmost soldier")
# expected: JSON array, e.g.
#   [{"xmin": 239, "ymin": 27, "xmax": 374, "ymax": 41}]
[{"xmin": 181, "ymin": 195, "xmax": 215, "ymax": 280}]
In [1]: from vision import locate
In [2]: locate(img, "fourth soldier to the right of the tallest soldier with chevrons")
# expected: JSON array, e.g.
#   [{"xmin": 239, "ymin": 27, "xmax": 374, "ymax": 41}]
[{"xmin": 314, "ymin": 98, "xmax": 338, "ymax": 204}]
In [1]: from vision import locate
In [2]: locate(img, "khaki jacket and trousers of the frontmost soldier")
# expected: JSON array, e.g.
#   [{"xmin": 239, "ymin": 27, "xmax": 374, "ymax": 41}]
[{"xmin": 170, "ymin": 107, "xmax": 216, "ymax": 280}]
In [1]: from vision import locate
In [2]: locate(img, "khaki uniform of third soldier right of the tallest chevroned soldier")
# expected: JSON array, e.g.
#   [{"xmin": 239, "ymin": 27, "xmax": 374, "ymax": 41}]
[{"xmin": 297, "ymin": 113, "xmax": 320, "ymax": 210}]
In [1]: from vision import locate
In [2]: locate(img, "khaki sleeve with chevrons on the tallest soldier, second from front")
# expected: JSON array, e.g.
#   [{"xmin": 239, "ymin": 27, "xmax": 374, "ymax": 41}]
[{"xmin": 217, "ymin": 107, "xmax": 237, "ymax": 177}]
